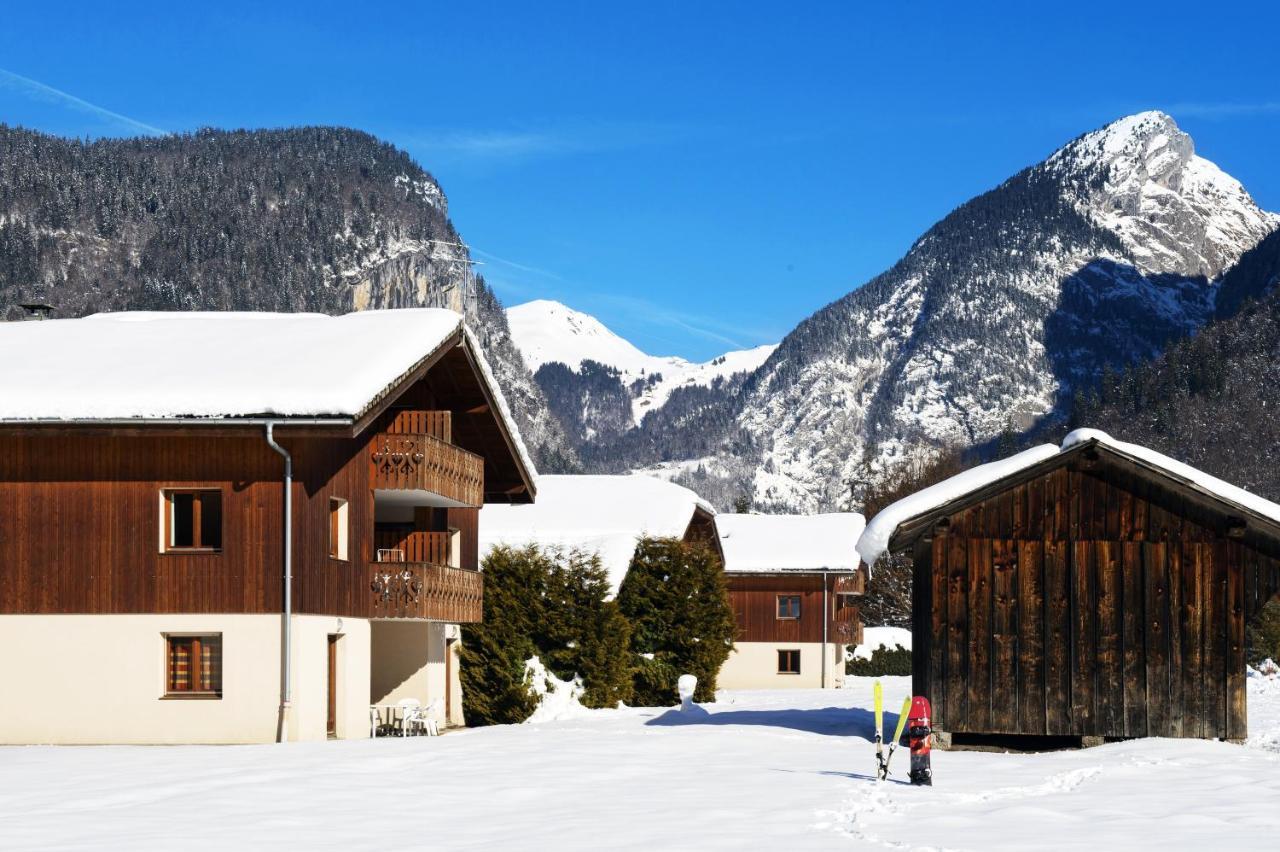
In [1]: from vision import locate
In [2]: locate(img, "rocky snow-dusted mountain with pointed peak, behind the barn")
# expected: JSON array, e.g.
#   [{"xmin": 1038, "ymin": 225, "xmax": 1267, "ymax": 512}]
[{"xmin": 614, "ymin": 113, "xmax": 1280, "ymax": 509}]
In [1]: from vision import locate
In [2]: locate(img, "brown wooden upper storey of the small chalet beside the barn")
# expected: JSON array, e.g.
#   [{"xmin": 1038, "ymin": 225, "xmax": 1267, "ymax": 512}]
[{"xmin": 724, "ymin": 572, "xmax": 865, "ymax": 645}]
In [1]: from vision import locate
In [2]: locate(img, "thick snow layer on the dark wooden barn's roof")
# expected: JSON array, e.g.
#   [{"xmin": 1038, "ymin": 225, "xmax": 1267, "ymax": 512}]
[{"xmin": 858, "ymin": 429, "xmax": 1280, "ymax": 564}]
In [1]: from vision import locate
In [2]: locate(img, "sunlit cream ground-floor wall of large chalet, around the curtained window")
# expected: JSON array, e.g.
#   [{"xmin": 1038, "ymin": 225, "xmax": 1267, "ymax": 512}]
[{"xmin": 0, "ymin": 614, "xmax": 370, "ymax": 743}]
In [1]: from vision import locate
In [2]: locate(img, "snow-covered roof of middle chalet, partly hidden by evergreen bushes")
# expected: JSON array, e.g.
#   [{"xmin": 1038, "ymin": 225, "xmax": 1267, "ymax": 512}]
[{"xmin": 480, "ymin": 475, "xmax": 716, "ymax": 594}]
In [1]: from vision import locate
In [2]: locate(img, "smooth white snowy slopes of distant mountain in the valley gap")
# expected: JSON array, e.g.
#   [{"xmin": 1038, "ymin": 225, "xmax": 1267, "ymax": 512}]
[{"xmin": 507, "ymin": 299, "xmax": 777, "ymax": 429}]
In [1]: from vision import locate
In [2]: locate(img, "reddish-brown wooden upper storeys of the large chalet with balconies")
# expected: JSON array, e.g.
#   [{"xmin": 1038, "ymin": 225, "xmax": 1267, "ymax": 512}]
[{"xmin": 0, "ymin": 342, "xmax": 530, "ymax": 622}]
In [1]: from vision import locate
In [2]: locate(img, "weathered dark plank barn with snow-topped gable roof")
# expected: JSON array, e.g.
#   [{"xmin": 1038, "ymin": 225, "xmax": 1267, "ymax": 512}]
[{"xmin": 859, "ymin": 430, "xmax": 1280, "ymax": 745}]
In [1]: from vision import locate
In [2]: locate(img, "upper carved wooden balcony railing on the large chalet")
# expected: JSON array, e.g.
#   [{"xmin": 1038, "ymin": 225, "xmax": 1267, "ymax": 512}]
[{"xmin": 369, "ymin": 432, "xmax": 484, "ymax": 507}]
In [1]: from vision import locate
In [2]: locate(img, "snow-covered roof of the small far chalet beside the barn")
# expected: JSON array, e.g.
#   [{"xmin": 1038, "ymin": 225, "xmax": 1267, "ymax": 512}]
[{"xmin": 716, "ymin": 512, "xmax": 867, "ymax": 573}]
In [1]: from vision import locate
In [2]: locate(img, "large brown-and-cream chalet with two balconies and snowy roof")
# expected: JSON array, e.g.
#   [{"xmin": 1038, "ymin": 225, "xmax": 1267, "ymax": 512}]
[{"xmin": 0, "ymin": 310, "xmax": 535, "ymax": 743}]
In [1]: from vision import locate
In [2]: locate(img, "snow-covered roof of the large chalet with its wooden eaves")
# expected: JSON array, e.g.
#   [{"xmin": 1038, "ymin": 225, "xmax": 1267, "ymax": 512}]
[{"xmin": 0, "ymin": 308, "xmax": 536, "ymax": 501}]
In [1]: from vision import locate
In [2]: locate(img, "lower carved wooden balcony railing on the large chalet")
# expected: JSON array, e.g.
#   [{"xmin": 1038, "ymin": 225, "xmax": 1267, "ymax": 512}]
[{"xmin": 369, "ymin": 562, "xmax": 484, "ymax": 623}]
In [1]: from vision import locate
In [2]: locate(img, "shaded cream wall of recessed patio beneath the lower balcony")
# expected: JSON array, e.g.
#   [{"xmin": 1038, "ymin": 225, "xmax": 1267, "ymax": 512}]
[{"xmin": 371, "ymin": 620, "xmax": 462, "ymax": 725}]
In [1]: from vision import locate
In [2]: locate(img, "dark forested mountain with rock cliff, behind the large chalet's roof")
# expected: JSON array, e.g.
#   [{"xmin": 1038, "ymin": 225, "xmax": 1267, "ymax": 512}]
[{"xmin": 0, "ymin": 125, "xmax": 576, "ymax": 469}]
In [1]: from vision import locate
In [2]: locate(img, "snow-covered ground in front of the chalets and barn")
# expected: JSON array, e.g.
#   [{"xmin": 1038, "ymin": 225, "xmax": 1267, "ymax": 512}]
[{"xmin": 0, "ymin": 678, "xmax": 1280, "ymax": 852}]
